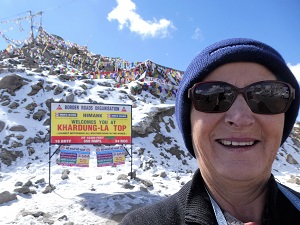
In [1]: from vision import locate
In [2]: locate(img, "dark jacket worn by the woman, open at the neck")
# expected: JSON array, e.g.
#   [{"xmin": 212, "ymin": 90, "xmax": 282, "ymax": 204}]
[{"xmin": 120, "ymin": 169, "xmax": 300, "ymax": 225}]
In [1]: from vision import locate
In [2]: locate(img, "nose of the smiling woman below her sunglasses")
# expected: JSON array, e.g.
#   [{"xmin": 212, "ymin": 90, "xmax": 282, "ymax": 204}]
[{"xmin": 225, "ymin": 94, "xmax": 255, "ymax": 128}]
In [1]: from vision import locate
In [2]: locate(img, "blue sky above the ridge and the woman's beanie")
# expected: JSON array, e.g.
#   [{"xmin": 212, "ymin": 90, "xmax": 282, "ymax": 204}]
[{"xmin": 0, "ymin": 0, "xmax": 300, "ymax": 76}]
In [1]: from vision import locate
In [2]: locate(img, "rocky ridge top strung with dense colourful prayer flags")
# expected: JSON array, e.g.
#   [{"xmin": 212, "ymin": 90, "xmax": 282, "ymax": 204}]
[{"xmin": 0, "ymin": 24, "xmax": 183, "ymax": 99}]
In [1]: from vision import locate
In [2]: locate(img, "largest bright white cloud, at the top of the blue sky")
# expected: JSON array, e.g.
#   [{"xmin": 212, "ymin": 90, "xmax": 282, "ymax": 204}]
[{"xmin": 107, "ymin": 0, "xmax": 175, "ymax": 38}]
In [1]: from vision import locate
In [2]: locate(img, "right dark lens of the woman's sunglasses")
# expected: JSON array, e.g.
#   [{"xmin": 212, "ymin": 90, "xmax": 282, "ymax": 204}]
[{"xmin": 246, "ymin": 82, "xmax": 291, "ymax": 114}]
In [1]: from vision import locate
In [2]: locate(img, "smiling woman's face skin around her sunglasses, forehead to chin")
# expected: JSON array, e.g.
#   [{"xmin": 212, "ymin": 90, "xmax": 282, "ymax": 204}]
[{"xmin": 191, "ymin": 62, "xmax": 284, "ymax": 181}]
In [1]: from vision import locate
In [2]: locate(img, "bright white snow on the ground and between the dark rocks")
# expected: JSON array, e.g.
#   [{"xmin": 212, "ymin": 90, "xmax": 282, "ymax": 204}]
[{"xmin": 0, "ymin": 60, "xmax": 300, "ymax": 225}]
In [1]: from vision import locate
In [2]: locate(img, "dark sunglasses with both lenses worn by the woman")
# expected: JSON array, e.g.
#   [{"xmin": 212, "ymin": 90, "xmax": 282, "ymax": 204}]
[{"xmin": 188, "ymin": 80, "xmax": 295, "ymax": 114}]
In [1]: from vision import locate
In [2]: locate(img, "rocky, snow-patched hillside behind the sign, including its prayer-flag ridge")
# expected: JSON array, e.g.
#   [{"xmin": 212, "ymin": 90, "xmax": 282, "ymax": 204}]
[{"xmin": 0, "ymin": 32, "xmax": 300, "ymax": 223}]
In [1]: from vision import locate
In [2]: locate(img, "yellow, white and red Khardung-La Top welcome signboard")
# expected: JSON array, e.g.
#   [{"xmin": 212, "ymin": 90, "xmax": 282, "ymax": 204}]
[{"xmin": 50, "ymin": 102, "xmax": 132, "ymax": 144}]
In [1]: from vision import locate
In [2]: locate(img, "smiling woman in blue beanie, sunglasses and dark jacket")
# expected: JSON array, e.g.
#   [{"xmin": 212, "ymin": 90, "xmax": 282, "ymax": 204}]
[{"xmin": 121, "ymin": 38, "xmax": 300, "ymax": 225}]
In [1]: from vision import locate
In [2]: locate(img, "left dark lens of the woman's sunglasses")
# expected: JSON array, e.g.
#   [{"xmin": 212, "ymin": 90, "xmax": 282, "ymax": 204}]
[{"xmin": 193, "ymin": 82, "xmax": 235, "ymax": 112}]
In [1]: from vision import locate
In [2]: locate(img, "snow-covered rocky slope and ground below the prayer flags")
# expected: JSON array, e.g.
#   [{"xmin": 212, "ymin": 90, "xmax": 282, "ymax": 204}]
[{"xmin": 0, "ymin": 41, "xmax": 300, "ymax": 224}]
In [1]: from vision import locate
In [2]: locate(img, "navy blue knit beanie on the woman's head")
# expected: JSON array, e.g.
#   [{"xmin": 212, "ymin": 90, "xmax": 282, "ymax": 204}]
[{"xmin": 175, "ymin": 38, "xmax": 300, "ymax": 157}]
